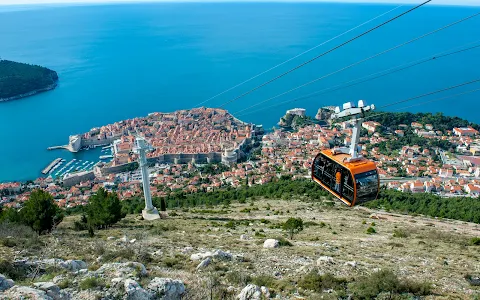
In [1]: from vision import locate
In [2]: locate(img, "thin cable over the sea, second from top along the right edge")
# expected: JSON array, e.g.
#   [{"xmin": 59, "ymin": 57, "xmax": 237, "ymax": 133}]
[{"xmin": 234, "ymin": 41, "xmax": 480, "ymax": 117}]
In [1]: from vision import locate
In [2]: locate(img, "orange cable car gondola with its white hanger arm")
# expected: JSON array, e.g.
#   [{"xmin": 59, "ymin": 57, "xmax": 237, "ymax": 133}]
[{"xmin": 312, "ymin": 100, "xmax": 380, "ymax": 206}]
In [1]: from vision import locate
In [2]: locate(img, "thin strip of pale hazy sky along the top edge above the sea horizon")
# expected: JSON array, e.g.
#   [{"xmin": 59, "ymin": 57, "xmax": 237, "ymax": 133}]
[{"xmin": 0, "ymin": 0, "xmax": 480, "ymax": 5}]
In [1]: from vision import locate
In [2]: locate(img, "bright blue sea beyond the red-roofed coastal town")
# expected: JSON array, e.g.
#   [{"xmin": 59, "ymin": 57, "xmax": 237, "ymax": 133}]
[{"xmin": 0, "ymin": 3, "xmax": 480, "ymax": 181}]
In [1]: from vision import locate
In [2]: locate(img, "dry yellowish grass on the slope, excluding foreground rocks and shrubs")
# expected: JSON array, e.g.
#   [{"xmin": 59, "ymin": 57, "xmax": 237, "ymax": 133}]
[{"xmin": 0, "ymin": 200, "xmax": 480, "ymax": 299}]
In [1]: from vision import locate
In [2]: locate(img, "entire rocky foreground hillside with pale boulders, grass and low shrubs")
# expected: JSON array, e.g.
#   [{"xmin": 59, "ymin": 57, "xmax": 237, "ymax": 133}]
[{"xmin": 0, "ymin": 199, "xmax": 480, "ymax": 299}]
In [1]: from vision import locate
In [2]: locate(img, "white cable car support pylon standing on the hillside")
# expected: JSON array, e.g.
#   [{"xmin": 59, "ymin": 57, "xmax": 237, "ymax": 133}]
[{"xmin": 133, "ymin": 135, "xmax": 160, "ymax": 220}]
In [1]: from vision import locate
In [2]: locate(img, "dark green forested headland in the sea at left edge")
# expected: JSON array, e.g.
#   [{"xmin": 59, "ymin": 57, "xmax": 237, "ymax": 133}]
[{"xmin": 0, "ymin": 60, "xmax": 58, "ymax": 102}]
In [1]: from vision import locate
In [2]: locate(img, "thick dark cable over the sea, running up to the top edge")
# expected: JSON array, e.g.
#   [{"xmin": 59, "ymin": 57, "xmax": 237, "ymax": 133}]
[{"xmin": 219, "ymin": 0, "xmax": 432, "ymax": 108}]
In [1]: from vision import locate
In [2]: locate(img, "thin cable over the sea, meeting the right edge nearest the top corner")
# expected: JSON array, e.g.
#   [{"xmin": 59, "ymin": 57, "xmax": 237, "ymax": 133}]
[{"xmin": 235, "ymin": 12, "xmax": 480, "ymax": 114}]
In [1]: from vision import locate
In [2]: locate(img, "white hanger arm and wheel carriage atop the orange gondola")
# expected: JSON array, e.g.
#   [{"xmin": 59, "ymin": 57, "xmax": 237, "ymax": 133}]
[{"xmin": 331, "ymin": 100, "xmax": 375, "ymax": 160}]
